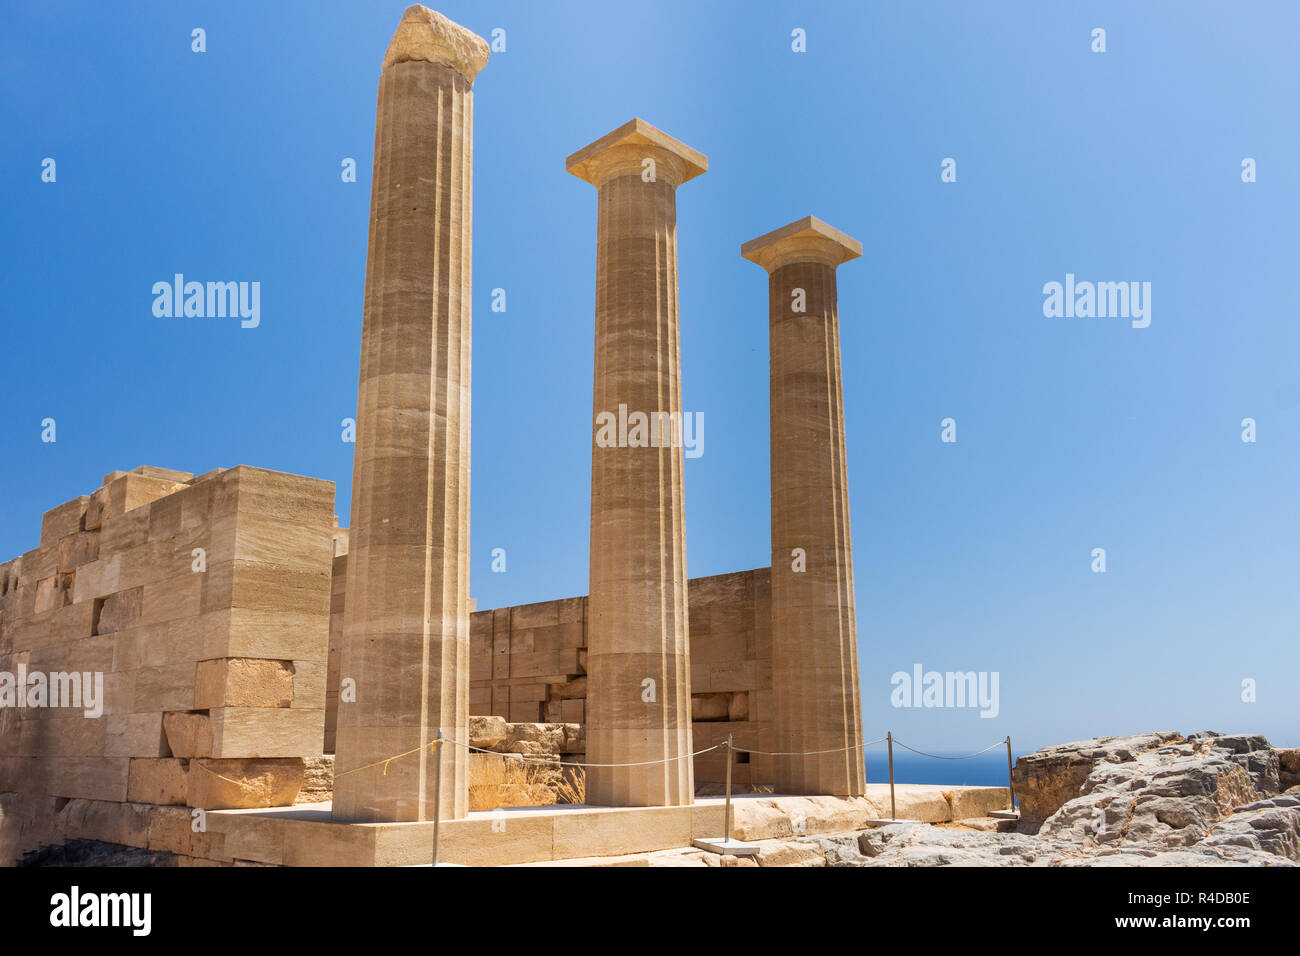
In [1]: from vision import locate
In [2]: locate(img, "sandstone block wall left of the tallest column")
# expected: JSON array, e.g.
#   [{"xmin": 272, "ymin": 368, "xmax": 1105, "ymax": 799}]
[{"xmin": 0, "ymin": 466, "xmax": 334, "ymax": 858}]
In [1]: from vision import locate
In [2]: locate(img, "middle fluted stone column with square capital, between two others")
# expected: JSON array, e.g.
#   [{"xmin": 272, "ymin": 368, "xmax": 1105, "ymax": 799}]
[{"xmin": 566, "ymin": 120, "xmax": 709, "ymax": 806}]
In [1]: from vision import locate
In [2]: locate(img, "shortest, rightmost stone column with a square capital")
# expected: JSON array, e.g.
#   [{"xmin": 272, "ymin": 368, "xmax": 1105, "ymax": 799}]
[{"xmin": 741, "ymin": 216, "xmax": 866, "ymax": 796}]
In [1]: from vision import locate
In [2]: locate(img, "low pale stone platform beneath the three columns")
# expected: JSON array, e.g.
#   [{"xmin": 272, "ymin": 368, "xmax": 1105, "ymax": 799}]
[{"xmin": 22, "ymin": 784, "xmax": 1009, "ymax": 866}]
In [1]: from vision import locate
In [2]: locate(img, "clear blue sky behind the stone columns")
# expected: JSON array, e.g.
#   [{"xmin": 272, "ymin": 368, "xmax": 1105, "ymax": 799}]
[{"xmin": 0, "ymin": 0, "xmax": 1300, "ymax": 752}]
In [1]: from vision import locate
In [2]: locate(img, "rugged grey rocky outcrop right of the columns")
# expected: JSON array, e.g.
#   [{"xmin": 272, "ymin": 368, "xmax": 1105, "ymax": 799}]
[{"xmin": 768, "ymin": 731, "xmax": 1300, "ymax": 866}]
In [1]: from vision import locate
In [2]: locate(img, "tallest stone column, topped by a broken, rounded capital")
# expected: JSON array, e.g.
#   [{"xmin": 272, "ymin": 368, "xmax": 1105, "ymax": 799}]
[{"xmin": 334, "ymin": 5, "xmax": 488, "ymax": 821}]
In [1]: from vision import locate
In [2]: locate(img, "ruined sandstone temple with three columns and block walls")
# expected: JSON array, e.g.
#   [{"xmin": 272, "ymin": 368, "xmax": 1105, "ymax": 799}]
[{"xmin": 0, "ymin": 5, "xmax": 866, "ymax": 861}]
